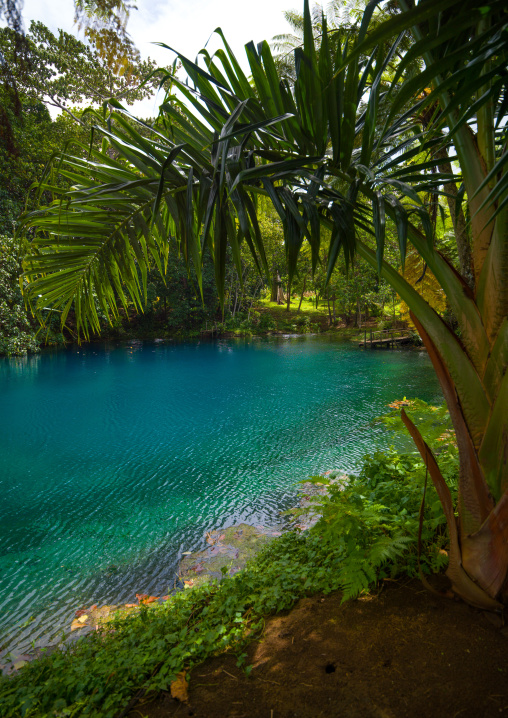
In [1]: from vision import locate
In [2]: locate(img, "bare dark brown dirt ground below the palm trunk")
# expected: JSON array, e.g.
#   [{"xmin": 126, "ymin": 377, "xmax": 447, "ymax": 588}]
[{"xmin": 128, "ymin": 581, "xmax": 508, "ymax": 718}]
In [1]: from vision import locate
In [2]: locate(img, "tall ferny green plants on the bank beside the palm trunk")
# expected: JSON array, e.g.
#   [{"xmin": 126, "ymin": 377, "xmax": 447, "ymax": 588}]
[{"xmin": 300, "ymin": 399, "xmax": 459, "ymax": 599}]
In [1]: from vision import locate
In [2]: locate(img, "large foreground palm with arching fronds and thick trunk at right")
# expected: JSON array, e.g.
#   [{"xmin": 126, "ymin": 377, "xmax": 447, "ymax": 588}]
[{"xmin": 19, "ymin": 0, "xmax": 508, "ymax": 610}]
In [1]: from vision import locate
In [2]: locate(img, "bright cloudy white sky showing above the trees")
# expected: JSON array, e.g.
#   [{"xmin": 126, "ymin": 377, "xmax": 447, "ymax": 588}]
[{"xmin": 18, "ymin": 0, "xmax": 303, "ymax": 117}]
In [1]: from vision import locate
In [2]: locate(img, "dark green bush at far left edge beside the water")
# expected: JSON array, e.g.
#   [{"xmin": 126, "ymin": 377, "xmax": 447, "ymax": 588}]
[{"xmin": 0, "ymin": 235, "xmax": 39, "ymax": 356}]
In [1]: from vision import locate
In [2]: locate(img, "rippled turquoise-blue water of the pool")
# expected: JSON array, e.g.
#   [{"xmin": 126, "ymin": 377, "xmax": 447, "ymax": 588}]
[{"xmin": 0, "ymin": 337, "xmax": 440, "ymax": 649}]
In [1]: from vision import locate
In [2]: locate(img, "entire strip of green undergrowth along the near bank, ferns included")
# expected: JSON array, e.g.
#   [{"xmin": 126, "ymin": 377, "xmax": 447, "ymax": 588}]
[{"xmin": 0, "ymin": 405, "xmax": 457, "ymax": 718}]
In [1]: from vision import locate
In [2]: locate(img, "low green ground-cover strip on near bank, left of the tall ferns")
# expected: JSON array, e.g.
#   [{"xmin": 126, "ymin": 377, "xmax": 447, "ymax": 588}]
[{"xmin": 0, "ymin": 533, "xmax": 358, "ymax": 718}]
